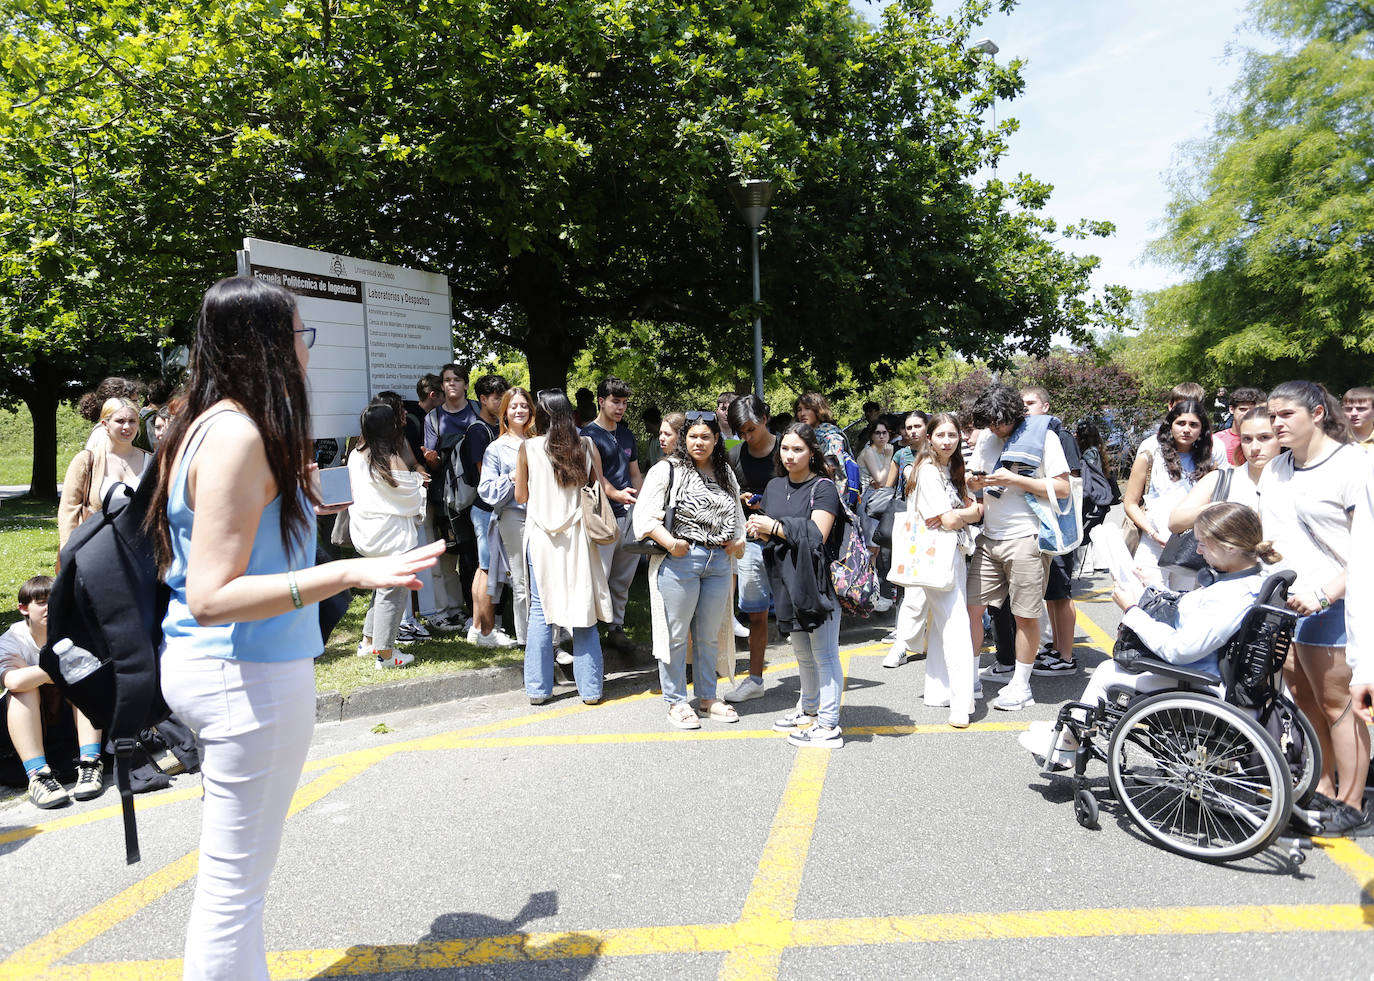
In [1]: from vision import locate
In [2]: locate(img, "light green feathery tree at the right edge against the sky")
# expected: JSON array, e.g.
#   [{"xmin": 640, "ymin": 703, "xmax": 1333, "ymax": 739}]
[{"xmin": 1139, "ymin": 0, "xmax": 1374, "ymax": 389}]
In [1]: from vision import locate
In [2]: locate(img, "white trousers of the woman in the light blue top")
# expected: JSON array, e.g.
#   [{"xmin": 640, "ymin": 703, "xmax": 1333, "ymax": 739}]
[{"xmin": 162, "ymin": 650, "xmax": 315, "ymax": 981}]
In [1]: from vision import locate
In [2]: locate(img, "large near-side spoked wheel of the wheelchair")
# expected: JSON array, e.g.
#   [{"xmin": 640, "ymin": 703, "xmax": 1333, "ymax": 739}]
[{"xmin": 1107, "ymin": 692, "xmax": 1293, "ymax": 861}]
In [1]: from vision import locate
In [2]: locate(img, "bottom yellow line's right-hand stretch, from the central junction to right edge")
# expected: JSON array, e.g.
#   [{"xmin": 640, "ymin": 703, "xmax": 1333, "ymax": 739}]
[{"xmin": 793, "ymin": 904, "xmax": 1374, "ymax": 947}]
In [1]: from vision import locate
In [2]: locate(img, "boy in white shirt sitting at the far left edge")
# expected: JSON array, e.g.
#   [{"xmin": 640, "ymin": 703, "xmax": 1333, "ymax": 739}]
[{"xmin": 0, "ymin": 576, "xmax": 104, "ymax": 809}]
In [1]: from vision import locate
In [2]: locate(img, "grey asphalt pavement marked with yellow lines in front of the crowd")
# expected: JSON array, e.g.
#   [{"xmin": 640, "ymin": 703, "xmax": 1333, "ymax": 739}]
[{"xmin": 0, "ymin": 566, "xmax": 1374, "ymax": 981}]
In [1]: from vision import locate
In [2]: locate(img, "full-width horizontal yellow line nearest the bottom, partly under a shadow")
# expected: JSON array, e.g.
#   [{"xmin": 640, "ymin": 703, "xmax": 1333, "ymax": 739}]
[{"xmin": 26, "ymin": 904, "xmax": 1374, "ymax": 981}]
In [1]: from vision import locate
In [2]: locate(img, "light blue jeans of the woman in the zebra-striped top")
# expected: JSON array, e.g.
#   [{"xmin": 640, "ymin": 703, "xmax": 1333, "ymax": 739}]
[{"xmin": 658, "ymin": 545, "xmax": 730, "ymax": 705}]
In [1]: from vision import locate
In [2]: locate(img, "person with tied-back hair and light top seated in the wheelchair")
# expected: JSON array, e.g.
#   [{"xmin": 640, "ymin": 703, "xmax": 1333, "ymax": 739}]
[{"xmin": 1020, "ymin": 501, "xmax": 1282, "ymax": 769}]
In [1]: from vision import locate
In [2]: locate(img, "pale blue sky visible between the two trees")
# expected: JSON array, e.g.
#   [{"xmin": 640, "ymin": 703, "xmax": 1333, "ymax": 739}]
[{"xmin": 856, "ymin": 0, "xmax": 1275, "ymax": 302}]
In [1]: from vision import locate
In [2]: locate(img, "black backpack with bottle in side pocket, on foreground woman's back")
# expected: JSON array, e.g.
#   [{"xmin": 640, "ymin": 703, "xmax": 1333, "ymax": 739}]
[{"xmin": 38, "ymin": 474, "xmax": 172, "ymax": 866}]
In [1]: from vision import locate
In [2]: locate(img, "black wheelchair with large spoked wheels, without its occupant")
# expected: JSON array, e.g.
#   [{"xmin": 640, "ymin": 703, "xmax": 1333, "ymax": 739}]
[{"xmin": 1046, "ymin": 572, "xmax": 1322, "ymax": 866}]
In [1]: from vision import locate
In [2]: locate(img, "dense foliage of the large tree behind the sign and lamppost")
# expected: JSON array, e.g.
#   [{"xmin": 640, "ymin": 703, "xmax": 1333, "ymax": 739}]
[{"xmin": 0, "ymin": 0, "xmax": 1121, "ymax": 469}]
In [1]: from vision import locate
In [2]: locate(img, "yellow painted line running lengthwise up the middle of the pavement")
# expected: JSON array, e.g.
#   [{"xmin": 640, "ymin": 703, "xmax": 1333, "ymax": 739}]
[{"xmin": 719, "ymin": 750, "xmax": 830, "ymax": 981}]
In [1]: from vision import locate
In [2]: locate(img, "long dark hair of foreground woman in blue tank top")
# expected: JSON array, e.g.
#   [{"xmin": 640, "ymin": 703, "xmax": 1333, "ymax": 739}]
[{"xmin": 146, "ymin": 276, "xmax": 319, "ymax": 570}]
